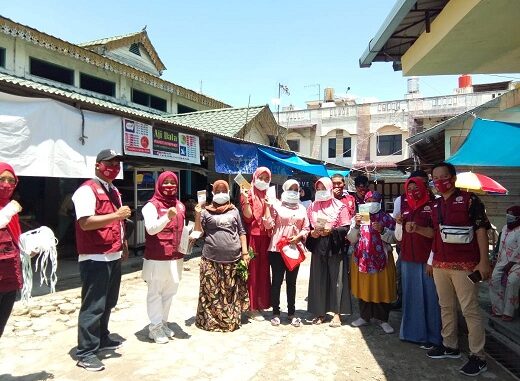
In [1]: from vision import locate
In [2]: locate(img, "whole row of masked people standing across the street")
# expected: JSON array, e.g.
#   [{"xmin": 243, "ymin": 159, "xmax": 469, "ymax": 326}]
[{"xmin": 0, "ymin": 150, "xmax": 520, "ymax": 375}]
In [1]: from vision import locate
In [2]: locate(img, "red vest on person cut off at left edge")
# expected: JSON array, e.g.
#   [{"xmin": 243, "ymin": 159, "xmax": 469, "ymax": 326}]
[{"xmin": 0, "ymin": 228, "xmax": 22, "ymax": 292}]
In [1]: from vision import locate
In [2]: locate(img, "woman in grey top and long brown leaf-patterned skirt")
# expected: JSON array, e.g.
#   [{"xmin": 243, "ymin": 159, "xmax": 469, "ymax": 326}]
[{"xmin": 195, "ymin": 180, "xmax": 249, "ymax": 332}]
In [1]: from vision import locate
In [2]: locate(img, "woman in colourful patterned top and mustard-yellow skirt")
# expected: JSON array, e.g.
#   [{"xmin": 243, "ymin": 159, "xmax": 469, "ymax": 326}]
[{"xmin": 348, "ymin": 191, "xmax": 397, "ymax": 333}]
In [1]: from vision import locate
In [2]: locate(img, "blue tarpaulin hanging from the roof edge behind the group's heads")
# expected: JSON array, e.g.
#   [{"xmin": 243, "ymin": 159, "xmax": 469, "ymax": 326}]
[{"xmin": 213, "ymin": 138, "xmax": 349, "ymax": 177}]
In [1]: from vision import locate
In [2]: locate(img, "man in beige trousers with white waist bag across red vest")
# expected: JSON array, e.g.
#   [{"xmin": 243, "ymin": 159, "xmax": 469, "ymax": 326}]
[{"xmin": 428, "ymin": 163, "xmax": 491, "ymax": 376}]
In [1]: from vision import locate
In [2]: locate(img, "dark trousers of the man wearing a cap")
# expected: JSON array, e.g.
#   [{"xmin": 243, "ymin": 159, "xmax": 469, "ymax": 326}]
[{"xmin": 76, "ymin": 259, "xmax": 121, "ymax": 359}]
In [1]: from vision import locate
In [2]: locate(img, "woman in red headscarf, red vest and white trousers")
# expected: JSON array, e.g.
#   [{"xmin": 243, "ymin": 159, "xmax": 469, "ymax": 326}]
[{"xmin": 142, "ymin": 171, "xmax": 186, "ymax": 344}]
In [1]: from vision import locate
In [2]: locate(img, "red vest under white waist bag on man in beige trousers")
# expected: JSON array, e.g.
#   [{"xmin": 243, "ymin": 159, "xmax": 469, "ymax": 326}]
[{"xmin": 432, "ymin": 189, "xmax": 480, "ymax": 262}]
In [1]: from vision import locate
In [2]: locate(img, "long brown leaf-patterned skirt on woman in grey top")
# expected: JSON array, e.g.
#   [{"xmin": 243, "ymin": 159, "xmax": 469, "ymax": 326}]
[{"xmin": 195, "ymin": 257, "xmax": 249, "ymax": 332}]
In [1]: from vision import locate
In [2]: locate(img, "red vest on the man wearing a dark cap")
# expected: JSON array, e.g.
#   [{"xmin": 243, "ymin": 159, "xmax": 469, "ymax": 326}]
[{"xmin": 76, "ymin": 180, "xmax": 122, "ymax": 255}]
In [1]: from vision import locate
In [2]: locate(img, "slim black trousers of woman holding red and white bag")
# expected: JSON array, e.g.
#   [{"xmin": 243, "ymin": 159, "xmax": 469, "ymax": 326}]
[{"xmin": 269, "ymin": 251, "xmax": 300, "ymax": 315}]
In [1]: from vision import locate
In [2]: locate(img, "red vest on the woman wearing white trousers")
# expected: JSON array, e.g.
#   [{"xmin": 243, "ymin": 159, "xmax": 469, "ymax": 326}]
[{"xmin": 144, "ymin": 200, "xmax": 186, "ymax": 261}]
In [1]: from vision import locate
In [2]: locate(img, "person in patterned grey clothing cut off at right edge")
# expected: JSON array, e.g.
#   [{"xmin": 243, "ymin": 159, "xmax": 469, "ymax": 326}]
[{"xmin": 489, "ymin": 205, "xmax": 520, "ymax": 321}]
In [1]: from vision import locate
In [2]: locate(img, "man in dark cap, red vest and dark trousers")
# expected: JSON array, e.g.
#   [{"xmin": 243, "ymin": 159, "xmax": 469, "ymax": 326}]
[{"xmin": 72, "ymin": 149, "xmax": 131, "ymax": 371}]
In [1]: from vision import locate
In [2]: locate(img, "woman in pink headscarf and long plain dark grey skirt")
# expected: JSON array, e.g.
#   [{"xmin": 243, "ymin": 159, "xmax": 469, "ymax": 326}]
[{"xmin": 307, "ymin": 177, "xmax": 352, "ymax": 327}]
